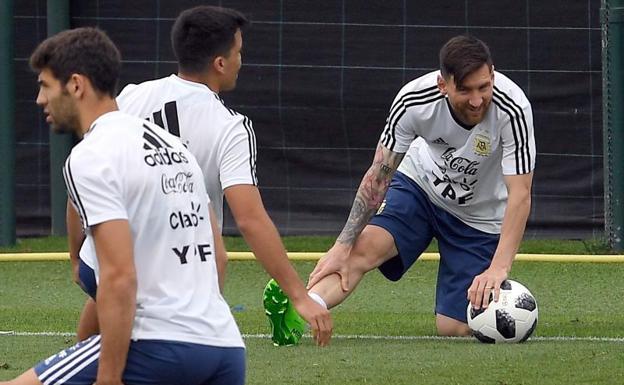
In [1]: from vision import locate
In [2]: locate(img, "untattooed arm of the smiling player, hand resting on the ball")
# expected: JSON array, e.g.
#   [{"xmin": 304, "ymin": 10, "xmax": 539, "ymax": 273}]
[{"xmin": 468, "ymin": 172, "xmax": 533, "ymax": 309}]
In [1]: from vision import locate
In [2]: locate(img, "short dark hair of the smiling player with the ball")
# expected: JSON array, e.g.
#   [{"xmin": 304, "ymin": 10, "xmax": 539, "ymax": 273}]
[{"xmin": 440, "ymin": 35, "xmax": 492, "ymax": 85}]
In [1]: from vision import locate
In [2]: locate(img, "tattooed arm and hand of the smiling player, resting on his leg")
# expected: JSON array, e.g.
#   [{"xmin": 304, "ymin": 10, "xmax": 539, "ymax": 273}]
[{"xmin": 308, "ymin": 143, "xmax": 405, "ymax": 291}]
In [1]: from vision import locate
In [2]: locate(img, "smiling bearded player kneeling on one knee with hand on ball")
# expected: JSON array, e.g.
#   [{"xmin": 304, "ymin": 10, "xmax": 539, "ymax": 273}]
[{"xmin": 268, "ymin": 36, "xmax": 535, "ymax": 336}]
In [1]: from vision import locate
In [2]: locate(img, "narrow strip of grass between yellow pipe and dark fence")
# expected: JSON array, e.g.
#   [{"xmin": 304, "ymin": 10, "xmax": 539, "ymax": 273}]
[{"xmin": 0, "ymin": 236, "xmax": 614, "ymax": 254}]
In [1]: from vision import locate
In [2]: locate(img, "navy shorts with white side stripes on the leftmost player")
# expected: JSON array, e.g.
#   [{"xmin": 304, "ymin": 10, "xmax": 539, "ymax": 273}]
[{"xmin": 34, "ymin": 335, "xmax": 245, "ymax": 385}]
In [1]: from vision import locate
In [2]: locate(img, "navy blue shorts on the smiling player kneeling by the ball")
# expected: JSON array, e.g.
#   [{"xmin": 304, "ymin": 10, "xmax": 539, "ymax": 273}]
[{"xmin": 370, "ymin": 172, "xmax": 499, "ymax": 322}]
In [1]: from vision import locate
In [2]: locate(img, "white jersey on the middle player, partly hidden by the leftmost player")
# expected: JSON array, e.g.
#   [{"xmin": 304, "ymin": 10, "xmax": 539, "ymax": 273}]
[{"xmin": 117, "ymin": 75, "xmax": 258, "ymax": 228}]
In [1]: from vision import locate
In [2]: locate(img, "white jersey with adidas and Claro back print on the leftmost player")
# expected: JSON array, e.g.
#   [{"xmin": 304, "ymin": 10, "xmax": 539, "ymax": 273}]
[{"xmin": 63, "ymin": 111, "xmax": 244, "ymax": 347}]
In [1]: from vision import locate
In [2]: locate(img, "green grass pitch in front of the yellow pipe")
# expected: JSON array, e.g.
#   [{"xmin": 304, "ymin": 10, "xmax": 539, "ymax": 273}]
[{"xmin": 0, "ymin": 245, "xmax": 624, "ymax": 385}]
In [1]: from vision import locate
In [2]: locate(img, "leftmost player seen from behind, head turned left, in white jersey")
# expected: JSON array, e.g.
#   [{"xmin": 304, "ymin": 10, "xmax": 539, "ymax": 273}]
[{"xmin": 3, "ymin": 28, "xmax": 245, "ymax": 385}]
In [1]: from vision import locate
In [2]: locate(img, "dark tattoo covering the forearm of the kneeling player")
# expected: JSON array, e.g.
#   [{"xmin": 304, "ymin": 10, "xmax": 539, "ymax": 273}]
[{"xmin": 337, "ymin": 146, "xmax": 404, "ymax": 244}]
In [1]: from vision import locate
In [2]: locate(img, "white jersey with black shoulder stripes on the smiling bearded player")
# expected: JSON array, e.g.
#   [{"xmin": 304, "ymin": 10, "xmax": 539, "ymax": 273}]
[{"xmin": 380, "ymin": 71, "xmax": 535, "ymax": 234}]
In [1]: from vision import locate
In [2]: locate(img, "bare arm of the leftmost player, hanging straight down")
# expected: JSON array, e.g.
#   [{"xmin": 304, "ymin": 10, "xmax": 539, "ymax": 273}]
[{"xmin": 91, "ymin": 220, "xmax": 137, "ymax": 384}]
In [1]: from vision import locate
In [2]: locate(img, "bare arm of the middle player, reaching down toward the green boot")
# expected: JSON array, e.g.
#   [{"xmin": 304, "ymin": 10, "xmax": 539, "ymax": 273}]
[{"xmin": 224, "ymin": 184, "xmax": 333, "ymax": 346}]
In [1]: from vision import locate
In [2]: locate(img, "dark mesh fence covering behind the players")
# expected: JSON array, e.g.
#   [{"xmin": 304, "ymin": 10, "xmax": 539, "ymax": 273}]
[{"xmin": 15, "ymin": 0, "xmax": 604, "ymax": 238}]
